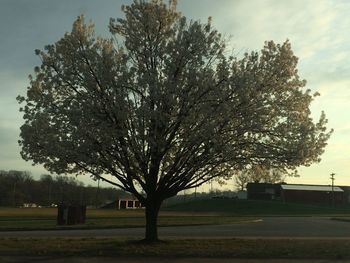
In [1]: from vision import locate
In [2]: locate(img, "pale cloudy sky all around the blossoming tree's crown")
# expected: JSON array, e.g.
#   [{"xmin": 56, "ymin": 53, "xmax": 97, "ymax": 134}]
[{"xmin": 0, "ymin": 0, "xmax": 350, "ymax": 189}]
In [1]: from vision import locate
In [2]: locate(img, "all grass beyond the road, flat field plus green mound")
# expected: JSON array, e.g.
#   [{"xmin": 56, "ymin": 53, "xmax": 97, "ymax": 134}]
[{"xmin": 0, "ymin": 199, "xmax": 350, "ymax": 231}]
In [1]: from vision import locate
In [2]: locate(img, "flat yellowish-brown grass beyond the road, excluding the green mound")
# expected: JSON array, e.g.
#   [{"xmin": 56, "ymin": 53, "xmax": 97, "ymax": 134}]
[{"xmin": 0, "ymin": 208, "xmax": 253, "ymax": 231}]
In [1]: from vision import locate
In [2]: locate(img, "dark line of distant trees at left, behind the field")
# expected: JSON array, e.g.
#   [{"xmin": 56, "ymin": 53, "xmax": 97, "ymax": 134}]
[{"xmin": 0, "ymin": 170, "xmax": 130, "ymax": 207}]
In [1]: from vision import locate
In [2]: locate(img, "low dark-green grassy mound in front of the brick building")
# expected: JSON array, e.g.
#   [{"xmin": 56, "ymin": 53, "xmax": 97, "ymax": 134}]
[{"xmin": 166, "ymin": 199, "xmax": 350, "ymax": 216}]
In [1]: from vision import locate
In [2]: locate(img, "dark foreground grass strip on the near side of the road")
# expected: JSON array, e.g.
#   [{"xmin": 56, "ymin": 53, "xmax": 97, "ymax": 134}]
[{"xmin": 0, "ymin": 238, "xmax": 350, "ymax": 259}]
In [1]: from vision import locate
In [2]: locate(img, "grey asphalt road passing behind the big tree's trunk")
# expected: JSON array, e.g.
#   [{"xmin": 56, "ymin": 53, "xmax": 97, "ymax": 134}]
[{"xmin": 0, "ymin": 217, "xmax": 350, "ymax": 238}]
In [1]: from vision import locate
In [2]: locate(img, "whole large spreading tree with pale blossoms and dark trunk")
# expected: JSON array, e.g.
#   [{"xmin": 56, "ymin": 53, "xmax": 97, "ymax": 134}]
[{"xmin": 18, "ymin": 0, "xmax": 330, "ymax": 241}]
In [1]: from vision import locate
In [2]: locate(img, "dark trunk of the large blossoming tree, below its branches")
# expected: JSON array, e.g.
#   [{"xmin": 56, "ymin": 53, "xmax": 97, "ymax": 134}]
[{"xmin": 145, "ymin": 200, "xmax": 162, "ymax": 243}]
